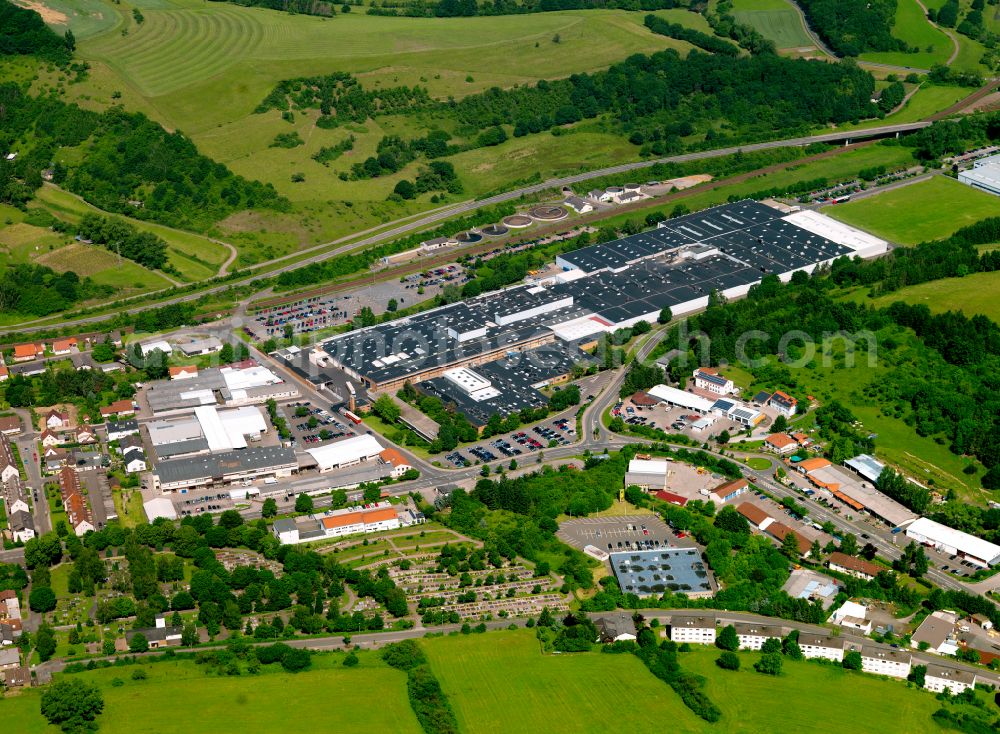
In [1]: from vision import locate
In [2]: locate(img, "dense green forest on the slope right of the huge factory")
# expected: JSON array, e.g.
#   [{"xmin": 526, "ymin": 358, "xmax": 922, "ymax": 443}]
[{"xmin": 665, "ymin": 246, "xmax": 1000, "ymax": 489}]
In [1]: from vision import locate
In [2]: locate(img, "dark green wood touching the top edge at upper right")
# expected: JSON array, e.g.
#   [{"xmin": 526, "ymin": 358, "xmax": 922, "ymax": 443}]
[{"xmin": 798, "ymin": 0, "xmax": 920, "ymax": 56}]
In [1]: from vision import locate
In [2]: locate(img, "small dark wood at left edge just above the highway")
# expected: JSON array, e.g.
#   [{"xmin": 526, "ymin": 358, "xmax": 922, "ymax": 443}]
[{"xmin": 0, "ymin": 263, "xmax": 114, "ymax": 316}]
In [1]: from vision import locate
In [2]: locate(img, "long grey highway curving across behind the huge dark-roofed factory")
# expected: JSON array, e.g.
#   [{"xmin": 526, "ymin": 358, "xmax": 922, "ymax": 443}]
[{"xmin": 0, "ymin": 121, "xmax": 931, "ymax": 335}]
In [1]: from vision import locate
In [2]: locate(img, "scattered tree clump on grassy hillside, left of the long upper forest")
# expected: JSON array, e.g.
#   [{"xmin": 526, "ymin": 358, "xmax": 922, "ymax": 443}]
[{"xmin": 254, "ymin": 72, "xmax": 431, "ymax": 122}]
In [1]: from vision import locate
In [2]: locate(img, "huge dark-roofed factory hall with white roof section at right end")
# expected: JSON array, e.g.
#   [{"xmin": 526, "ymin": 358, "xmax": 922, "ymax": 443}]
[{"xmin": 318, "ymin": 201, "xmax": 887, "ymax": 406}]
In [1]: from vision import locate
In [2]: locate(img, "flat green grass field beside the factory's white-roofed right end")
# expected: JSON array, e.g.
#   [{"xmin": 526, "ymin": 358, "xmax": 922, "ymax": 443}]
[{"xmin": 823, "ymin": 176, "xmax": 1000, "ymax": 245}]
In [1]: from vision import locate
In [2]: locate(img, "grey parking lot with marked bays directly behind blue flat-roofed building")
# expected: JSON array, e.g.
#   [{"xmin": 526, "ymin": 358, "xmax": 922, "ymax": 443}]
[{"xmin": 556, "ymin": 515, "xmax": 696, "ymax": 553}]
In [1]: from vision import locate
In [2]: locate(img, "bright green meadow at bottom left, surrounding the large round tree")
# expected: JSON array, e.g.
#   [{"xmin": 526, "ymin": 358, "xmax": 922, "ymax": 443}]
[{"xmin": 0, "ymin": 655, "xmax": 421, "ymax": 734}]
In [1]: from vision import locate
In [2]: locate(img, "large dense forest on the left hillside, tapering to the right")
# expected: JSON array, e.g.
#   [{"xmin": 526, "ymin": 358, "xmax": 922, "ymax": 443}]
[{"xmin": 0, "ymin": 83, "xmax": 289, "ymax": 229}]
